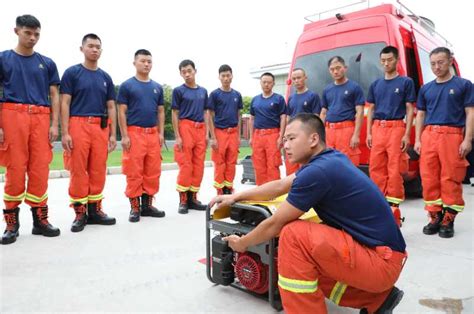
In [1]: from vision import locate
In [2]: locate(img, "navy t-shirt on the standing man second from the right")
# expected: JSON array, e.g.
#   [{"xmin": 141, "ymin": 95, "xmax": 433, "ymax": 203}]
[{"xmin": 367, "ymin": 76, "xmax": 416, "ymax": 120}]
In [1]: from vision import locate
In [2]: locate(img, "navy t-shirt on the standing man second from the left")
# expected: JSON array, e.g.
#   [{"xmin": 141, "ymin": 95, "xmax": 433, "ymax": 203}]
[{"xmin": 60, "ymin": 64, "xmax": 115, "ymax": 117}]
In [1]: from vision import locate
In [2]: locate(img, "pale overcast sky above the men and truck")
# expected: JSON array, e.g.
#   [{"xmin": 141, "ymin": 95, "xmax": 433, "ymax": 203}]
[{"xmin": 0, "ymin": 0, "xmax": 474, "ymax": 96}]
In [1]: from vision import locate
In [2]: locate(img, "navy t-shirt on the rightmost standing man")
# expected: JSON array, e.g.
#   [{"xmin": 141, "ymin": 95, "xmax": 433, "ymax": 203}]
[{"xmin": 416, "ymin": 76, "xmax": 474, "ymax": 127}]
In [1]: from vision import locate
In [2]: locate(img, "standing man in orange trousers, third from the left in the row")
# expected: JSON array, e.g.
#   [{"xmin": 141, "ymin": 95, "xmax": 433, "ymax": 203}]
[{"xmin": 117, "ymin": 49, "xmax": 165, "ymax": 222}]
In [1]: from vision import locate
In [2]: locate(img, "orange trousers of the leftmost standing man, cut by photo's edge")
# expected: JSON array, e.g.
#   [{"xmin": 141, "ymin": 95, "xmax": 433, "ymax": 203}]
[{"xmin": 0, "ymin": 103, "xmax": 53, "ymax": 209}]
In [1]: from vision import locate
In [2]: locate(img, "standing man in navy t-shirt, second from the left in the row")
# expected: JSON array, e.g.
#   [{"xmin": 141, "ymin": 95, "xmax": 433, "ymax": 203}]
[{"xmin": 60, "ymin": 34, "xmax": 117, "ymax": 232}]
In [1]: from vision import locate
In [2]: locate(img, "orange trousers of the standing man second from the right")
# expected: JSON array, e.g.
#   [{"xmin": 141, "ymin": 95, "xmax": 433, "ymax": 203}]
[{"xmin": 369, "ymin": 120, "xmax": 408, "ymax": 204}]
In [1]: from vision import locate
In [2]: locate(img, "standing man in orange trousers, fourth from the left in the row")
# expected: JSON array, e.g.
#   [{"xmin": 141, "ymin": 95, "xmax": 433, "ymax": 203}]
[{"xmin": 171, "ymin": 60, "xmax": 209, "ymax": 214}]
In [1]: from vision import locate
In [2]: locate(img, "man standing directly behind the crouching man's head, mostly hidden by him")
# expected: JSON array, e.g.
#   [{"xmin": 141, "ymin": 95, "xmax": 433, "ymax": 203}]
[{"xmin": 285, "ymin": 68, "xmax": 321, "ymax": 176}]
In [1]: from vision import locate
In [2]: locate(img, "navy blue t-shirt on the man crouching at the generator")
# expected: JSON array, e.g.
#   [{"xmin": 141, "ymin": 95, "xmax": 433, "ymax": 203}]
[{"xmin": 286, "ymin": 149, "xmax": 406, "ymax": 252}]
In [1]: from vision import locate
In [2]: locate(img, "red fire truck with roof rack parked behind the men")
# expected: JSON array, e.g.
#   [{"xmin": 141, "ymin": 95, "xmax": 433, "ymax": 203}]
[{"xmin": 287, "ymin": 1, "xmax": 459, "ymax": 195}]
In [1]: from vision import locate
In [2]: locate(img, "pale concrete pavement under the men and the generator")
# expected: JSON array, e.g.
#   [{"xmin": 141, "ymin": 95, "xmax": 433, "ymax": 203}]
[{"xmin": 0, "ymin": 166, "xmax": 474, "ymax": 313}]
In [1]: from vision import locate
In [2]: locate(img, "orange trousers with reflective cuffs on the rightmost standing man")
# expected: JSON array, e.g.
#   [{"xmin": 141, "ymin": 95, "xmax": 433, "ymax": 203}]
[{"xmin": 420, "ymin": 125, "xmax": 468, "ymax": 212}]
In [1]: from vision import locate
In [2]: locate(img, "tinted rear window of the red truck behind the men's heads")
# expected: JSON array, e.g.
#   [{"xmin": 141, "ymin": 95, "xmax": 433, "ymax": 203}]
[{"xmin": 292, "ymin": 42, "xmax": 386, "ymax": 95}]
